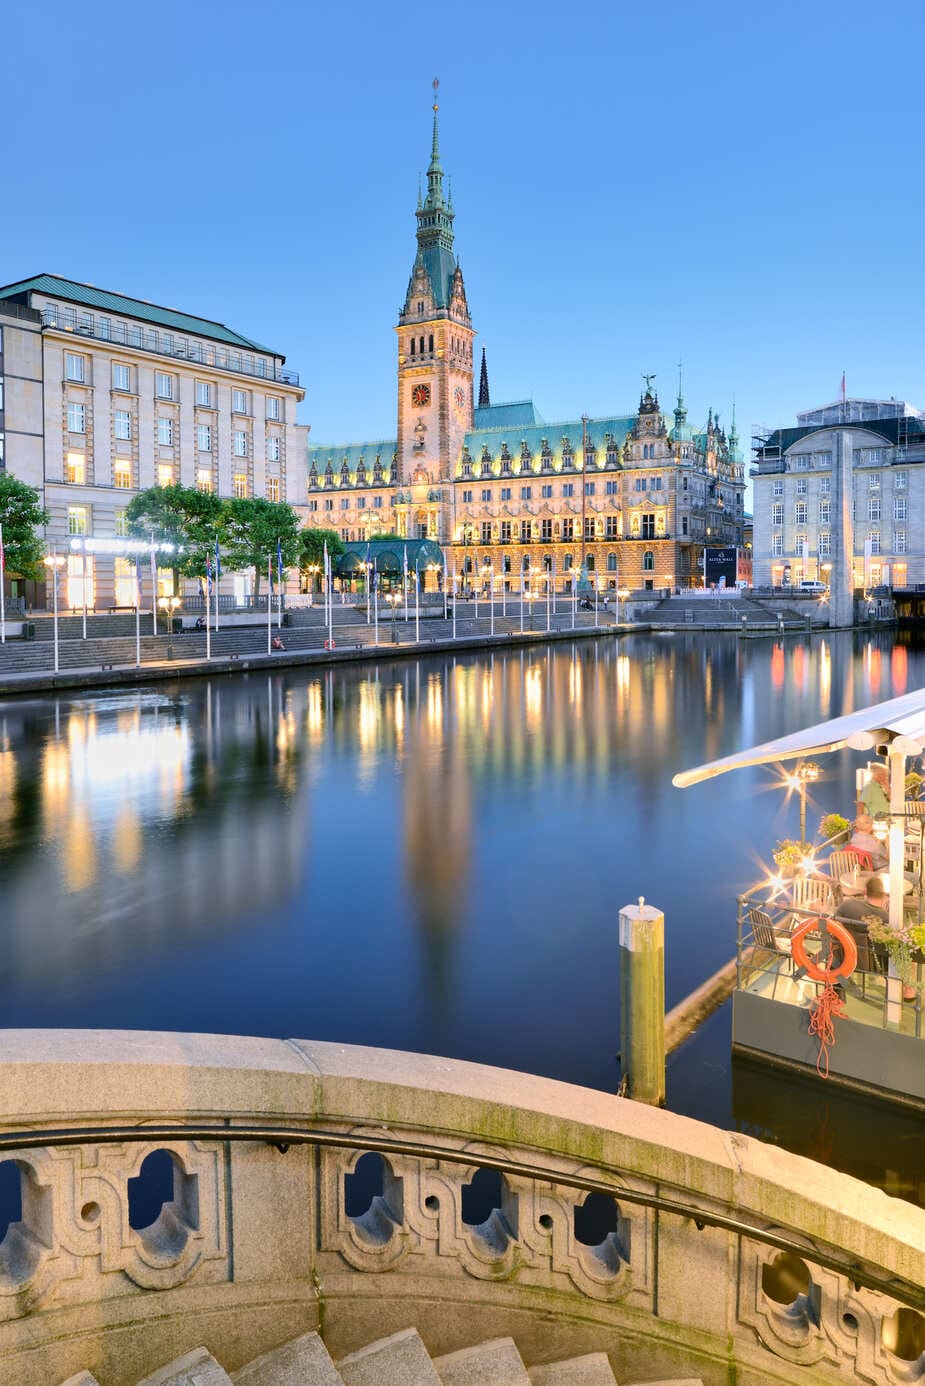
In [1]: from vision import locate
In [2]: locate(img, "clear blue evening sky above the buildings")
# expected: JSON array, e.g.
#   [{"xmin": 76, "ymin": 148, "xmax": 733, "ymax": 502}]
[{"xmin": 0, "ymin": 0, "xmax": 925, "ymax": 471}]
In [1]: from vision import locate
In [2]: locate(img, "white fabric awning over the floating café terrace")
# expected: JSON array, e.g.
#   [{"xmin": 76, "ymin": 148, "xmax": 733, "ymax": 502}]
[{"xmin": 671, "ymin": 689, "xmax": 925, "ymax": 789}]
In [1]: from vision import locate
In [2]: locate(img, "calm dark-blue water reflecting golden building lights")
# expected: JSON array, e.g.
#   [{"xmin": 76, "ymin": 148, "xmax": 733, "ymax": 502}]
[{"xmin": 0, "ymin": 635, "xmax": 925, "ymax": 1196}]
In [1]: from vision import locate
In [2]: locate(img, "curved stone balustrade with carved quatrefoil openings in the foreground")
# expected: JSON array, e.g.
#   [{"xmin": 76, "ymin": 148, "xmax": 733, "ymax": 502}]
[{"xmin": 0, "ymin": 1031, "xmax": 925, "ymax": 1386}]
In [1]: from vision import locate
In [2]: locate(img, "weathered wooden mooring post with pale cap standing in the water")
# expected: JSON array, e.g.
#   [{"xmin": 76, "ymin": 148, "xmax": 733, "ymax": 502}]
[{"xmin": 620, "ymin": 895, "xmax": 664, "ymax": 1107}]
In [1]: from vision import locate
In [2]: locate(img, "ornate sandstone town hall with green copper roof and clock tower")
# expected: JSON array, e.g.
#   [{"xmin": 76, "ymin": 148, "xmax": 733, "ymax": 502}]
[{"xmin": 308, "ymin": 94, "xmax": 745, "ymax": 592}]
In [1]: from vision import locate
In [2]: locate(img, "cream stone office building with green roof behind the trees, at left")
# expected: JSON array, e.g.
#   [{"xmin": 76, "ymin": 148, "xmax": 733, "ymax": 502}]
[{"xmin": 0, "ymin": 274, "xmax": 308, "ymax": 611}]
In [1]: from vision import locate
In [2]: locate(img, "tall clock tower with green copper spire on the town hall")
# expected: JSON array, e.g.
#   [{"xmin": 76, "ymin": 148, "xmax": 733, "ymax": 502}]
[{"xmin": 395, "ymin": 82, "xmax": 474, "ymax": 543}]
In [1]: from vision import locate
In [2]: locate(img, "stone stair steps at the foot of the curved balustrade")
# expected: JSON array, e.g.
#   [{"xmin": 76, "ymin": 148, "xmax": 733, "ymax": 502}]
[{"xmin": 61, "ymin": 1328, "xmax": 703, "ymax": 1386}]
